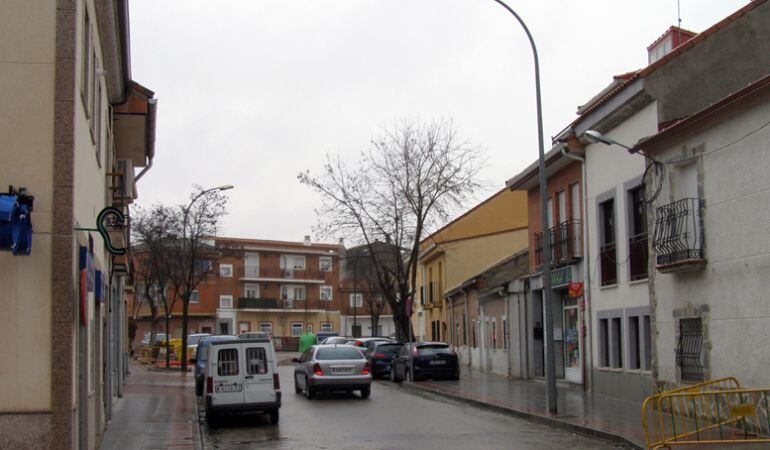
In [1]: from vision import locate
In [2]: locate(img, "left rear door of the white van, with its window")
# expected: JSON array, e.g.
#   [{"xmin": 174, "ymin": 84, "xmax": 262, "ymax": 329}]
[{"xmin": 209, "ymin": 344, "xmax": 243, "ymax": 406}]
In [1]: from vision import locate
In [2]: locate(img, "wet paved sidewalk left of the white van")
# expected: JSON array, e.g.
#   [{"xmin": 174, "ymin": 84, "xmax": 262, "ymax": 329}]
[{"xmin": 99, "ymin": 362, "xmax": 203, "ymax": 450}]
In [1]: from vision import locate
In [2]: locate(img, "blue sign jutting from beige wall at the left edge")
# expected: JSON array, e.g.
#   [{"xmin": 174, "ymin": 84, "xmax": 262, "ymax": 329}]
[{"xmin": 0, "ymin": 189, "xmax": 32, "ymax": 255}]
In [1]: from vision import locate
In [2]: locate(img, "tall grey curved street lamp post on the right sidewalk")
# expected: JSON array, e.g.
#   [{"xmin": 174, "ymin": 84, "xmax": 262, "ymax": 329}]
[{"xmin": 493, "ymin": 0, "xmax": 557, "ymax": 414}]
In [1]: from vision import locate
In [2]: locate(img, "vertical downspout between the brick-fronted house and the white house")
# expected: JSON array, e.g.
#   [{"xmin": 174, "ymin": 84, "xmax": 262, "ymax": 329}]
[{"xmin": 561, "ymin": 145, "xmax": 593, "ymax": 391}]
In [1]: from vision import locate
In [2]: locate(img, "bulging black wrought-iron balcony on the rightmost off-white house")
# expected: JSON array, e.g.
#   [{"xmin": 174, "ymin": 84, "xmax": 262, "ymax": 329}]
[{"xmin": 652, "ymin": 198, "xmax": 706, "ymax": 273}]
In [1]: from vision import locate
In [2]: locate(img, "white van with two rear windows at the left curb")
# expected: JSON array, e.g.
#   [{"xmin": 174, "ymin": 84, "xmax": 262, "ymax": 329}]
[{"xmin": 205, "ymin": 338, "xmax": 281, "ymax": 424}]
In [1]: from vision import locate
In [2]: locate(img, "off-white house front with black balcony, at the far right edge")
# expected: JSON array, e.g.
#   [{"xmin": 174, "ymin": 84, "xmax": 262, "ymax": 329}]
[{"xmin": 635, "ymin": 75, "xmax": 770, "ymax": 387}]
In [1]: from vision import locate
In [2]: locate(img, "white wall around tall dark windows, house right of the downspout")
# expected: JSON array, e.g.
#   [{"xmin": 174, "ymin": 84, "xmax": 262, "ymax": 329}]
[{"xmin": 585, "ymin": 102, "xmax": 658, "ymax": 372}]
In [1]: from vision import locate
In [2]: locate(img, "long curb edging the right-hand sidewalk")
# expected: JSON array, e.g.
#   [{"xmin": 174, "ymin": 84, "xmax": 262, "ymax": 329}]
[{"xmin": 401, "ymin": 381, "xmax": 643, "ymax": 450}]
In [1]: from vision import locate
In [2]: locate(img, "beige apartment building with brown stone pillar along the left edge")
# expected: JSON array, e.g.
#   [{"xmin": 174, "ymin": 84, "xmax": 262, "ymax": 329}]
[{"xmin": 0, "ymin": 0, "xmax": 156, "ymax": 449}]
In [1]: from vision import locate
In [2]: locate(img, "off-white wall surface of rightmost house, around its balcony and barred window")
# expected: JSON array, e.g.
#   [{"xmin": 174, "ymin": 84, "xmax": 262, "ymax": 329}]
[{"xmin": 655, "ymin": 94, "xmax": 770, "ymax": 387}]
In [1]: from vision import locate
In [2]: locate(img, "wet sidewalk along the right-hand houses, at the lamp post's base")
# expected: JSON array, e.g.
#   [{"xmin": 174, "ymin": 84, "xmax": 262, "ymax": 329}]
[{"xmin": 403, "ymin": 366, "xmax": 644, "ymax": 448}]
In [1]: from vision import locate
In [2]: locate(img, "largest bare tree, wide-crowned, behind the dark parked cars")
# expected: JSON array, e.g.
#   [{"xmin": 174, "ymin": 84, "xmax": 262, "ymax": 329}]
[{"xmin": 298, "ymin": 121, "xmax": 483, "ymax": 339}]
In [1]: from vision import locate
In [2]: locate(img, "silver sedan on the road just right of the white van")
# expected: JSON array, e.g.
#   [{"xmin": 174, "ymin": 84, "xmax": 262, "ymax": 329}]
[{"xmin": 292, "ymin": 345, "xmax": 372, "ymax": 399}]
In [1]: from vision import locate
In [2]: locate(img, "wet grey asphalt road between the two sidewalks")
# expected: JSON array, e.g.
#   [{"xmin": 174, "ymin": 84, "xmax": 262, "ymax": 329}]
[{"xmin": 199, "ymin": 366, "xmax": 616, "ymax": 450}]
